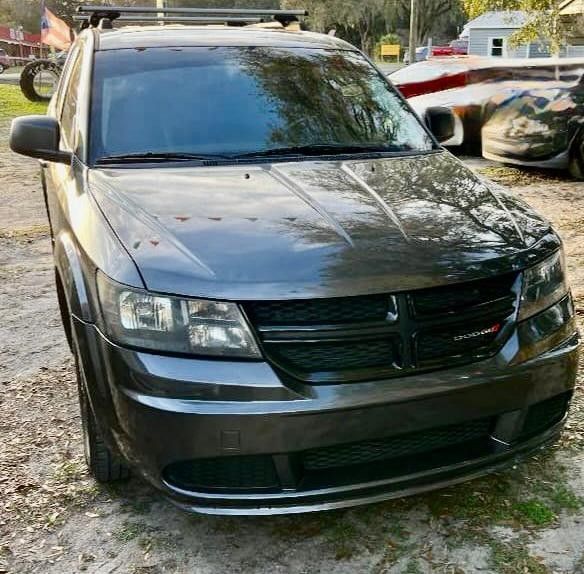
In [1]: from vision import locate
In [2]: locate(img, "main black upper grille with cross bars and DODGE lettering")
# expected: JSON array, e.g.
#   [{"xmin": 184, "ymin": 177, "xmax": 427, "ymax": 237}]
[{"xmin": 244, "ymin": 274, "xmax": 518, "ymax": 384}]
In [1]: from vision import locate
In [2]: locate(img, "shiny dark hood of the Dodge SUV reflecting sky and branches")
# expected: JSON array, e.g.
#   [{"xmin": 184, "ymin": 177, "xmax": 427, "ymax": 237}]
[{"xmin": 88, "ymin": 152, "xmax": 558, "ymax": 300}]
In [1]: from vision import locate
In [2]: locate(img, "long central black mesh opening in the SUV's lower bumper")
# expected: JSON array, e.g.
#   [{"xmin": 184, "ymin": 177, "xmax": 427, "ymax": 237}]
[{"xmin": 303, "ymin": 419, "xmax": 492, "ymax": 470}]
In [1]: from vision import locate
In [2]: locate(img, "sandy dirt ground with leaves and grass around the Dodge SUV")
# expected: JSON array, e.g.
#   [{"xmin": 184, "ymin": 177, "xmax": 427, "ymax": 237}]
[{"xmin": 0, "ymin": 119, "xmax": 584, "ymax": 574}]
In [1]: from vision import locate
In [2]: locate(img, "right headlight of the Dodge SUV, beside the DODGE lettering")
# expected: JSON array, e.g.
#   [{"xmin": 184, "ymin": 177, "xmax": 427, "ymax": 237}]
[{"xmin": 519, "ymin": 249, "xmax": 568, "ymax": 321}]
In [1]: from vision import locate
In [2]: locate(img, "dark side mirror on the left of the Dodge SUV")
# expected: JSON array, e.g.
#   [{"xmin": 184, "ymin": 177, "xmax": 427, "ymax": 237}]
[{"xmin": 10, "ymin": 116, "xmax": 72, "ymax": 163}]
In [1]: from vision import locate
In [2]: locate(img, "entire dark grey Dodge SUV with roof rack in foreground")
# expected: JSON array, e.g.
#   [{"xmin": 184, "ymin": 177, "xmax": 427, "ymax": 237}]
[{"xmin": 11, "ymin": 8, "xmax": 579, "ymax": 514}]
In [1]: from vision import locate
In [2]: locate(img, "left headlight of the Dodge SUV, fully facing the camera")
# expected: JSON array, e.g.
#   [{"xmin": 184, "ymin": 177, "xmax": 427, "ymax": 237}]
[{"xmin": 97, "ymin": 273, "xmax": 261, "ymax": 359}]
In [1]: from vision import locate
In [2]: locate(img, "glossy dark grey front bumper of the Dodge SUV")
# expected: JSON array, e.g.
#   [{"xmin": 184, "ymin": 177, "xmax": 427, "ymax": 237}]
[{"xmin": 75, "ymin": 306, "xmax": 579, "ymax": 515}]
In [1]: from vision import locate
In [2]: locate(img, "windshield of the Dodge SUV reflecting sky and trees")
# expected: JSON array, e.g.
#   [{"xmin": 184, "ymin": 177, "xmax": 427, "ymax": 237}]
[{"xmin": 90, "ymin": 47, "xmax": 434, "ymax": 164}]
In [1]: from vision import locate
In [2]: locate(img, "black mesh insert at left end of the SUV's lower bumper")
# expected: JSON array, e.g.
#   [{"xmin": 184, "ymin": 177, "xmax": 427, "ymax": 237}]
[{"xmin": 164, "ymin": 455, "xmax": 280, "ymax": 491}]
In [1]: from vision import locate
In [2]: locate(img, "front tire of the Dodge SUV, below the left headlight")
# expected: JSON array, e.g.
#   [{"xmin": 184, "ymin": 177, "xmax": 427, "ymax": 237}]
[{"xmin": 75, "ymin": 352, "xmax": 130, "ymax": 483}]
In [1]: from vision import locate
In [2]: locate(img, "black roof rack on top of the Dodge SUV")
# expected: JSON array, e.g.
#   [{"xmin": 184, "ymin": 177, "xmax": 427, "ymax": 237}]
[{"xmin": 77, "ymin": 5, "xmax": 308, "ymax": 27}]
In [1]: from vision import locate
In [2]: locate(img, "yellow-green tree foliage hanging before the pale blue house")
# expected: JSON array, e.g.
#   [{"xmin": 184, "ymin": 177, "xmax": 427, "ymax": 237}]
[{"xmin": 462, "ymin": 0, "xmax": 584, "ymax": 53}]
